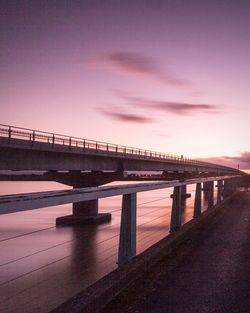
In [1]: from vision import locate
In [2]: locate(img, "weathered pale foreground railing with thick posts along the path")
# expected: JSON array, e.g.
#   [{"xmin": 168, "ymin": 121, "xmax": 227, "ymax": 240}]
[{"xmin": 0, "ymin": 175, "xmax": 241, "ymax": 264}]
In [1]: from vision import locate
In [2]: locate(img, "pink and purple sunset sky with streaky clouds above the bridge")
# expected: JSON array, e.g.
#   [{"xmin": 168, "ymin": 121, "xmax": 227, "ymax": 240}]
[{"xmin": 0, "ymin": 0, "xmax": 250, "ymax": 168}]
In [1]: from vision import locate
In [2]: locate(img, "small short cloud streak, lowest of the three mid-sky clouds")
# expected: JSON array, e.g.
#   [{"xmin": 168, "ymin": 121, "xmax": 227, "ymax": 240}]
[{"xmin": 100, "ymin": 108, "xmax": 153, "ymax": 124}]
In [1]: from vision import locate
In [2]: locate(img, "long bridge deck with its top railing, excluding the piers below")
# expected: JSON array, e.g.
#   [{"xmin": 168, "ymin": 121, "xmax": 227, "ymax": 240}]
[{"xmin": 0, "ymin": 125, "xmax": 239, "ymax": 175}]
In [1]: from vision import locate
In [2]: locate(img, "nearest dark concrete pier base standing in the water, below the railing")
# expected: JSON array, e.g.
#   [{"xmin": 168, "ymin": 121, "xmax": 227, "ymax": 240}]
[{"xmin": 56, "ymin": 199, "xmax": 111, "ymax": 225}]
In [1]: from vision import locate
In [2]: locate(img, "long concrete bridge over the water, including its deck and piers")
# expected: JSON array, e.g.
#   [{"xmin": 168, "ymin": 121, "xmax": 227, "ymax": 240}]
[{"xmin": 0, "ymin": 125, "xmax": 242, "ymax": 224}]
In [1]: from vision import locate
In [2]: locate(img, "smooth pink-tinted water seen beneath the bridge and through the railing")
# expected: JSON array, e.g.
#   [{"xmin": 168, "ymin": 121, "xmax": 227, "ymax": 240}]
[{"xmin": 0, "ymin": 182, "xmax": 211, "ymax": 313}]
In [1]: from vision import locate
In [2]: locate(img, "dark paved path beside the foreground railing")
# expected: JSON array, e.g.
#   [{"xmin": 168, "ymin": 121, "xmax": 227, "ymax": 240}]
[{"xmin": 104, "ymin": 191, "xmax": 250, "ymax": 313}]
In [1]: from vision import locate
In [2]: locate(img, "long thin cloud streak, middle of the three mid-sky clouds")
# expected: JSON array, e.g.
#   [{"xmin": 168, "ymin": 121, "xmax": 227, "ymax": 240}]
[{"xmin": 120, "ymin": 94, "xmax": 221, "ymax": 115}]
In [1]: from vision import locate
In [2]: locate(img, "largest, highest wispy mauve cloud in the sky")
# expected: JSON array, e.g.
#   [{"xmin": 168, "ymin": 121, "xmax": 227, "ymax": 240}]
[{"xmin": 88, "ymin": 52, "xmax": 191, "ymax": 87}]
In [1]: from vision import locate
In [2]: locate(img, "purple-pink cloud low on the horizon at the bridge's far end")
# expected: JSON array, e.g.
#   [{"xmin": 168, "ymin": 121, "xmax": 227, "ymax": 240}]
[{"xmin": 199, "ymin": 151, "xmax": 250, "ymax": 169}]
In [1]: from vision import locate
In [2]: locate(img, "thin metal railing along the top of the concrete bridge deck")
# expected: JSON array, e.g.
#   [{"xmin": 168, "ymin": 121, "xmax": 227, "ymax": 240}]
[{"xmin": 0, "ymin": 124, "xmax": 238, "ymax": 170}]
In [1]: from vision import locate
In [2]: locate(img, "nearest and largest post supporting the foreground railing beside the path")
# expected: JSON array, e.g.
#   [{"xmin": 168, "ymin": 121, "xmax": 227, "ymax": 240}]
[{"xmin": 118, "ymin": 193, "xmax": 136, "ymax": 264}]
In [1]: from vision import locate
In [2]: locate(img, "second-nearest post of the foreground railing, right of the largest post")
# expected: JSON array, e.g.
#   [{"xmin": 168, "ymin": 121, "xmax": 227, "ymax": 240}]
[{"xmin": 170, "ymin": 186, "xmax": 182, "ymax": 233}]
